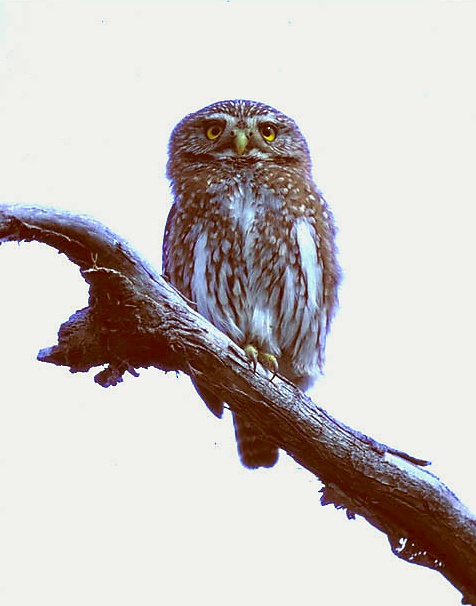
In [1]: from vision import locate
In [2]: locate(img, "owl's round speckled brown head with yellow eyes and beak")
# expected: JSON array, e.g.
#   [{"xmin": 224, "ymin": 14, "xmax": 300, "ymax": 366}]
[{"xmin": 167, "ymin": 99, "xmax": 311, "ymax": 179}]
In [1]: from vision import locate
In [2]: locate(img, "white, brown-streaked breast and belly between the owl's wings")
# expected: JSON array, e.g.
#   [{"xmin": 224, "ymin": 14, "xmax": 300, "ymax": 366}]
[{"xmin": 191, "ymin": 182, "xmax": 322, "ymax": 374}]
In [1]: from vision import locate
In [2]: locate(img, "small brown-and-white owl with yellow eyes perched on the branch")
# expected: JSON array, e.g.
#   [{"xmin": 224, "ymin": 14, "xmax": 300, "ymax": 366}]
[{"xmin": 163, "ymin": 100, "xmax": 341, "ymax": 468}]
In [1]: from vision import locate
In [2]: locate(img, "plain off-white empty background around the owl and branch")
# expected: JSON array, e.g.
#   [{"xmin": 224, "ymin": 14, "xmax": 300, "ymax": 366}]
[{"xmin": 0, "ymin": 1, "xmax": 476, "ymax": 606}]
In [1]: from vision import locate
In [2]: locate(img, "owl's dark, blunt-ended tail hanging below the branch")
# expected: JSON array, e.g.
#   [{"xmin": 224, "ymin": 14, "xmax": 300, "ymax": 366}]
[{"xmin": 233, "ymin": 414, "xmax": 279, "ymax": 469}]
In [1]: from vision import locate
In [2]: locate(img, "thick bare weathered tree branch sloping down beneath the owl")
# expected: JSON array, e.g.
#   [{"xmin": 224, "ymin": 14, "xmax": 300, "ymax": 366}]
[{"xmin": 0, "ymin": 206, "xmax": 476, "ymax": 606}]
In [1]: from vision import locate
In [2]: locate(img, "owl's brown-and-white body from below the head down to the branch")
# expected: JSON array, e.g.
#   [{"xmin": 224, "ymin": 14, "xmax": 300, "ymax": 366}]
[{"xmin": 164, "ymin": 164, "xmax": 332, "ymax": 386}]
